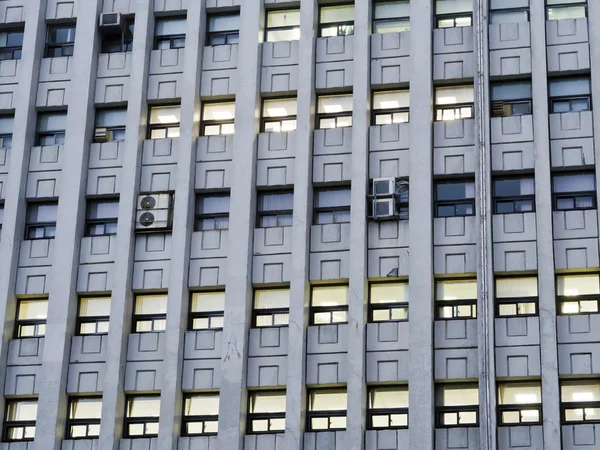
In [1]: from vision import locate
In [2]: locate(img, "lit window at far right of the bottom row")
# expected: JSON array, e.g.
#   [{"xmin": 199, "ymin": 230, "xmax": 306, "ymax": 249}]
[{"xmin": 560, "ymin": 380, "xmax": 600, "ymax": 424}]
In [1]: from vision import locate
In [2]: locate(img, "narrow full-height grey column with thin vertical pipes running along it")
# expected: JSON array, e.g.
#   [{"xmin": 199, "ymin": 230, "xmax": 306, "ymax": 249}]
[{"xmin": 473, "ymin": 0, "xmax": 496, "ymax": 450}]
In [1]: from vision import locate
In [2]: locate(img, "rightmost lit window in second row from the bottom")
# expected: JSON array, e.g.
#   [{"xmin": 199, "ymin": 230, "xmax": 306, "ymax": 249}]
[{"xmin": 556, "ymin": 274, "xmax": 600, "ymax": 314}]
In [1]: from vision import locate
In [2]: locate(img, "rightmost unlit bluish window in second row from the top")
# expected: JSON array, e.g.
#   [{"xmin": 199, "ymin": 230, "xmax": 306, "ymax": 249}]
[{"xmin": 548, "ymin": 77, "xmax": 592, "ymax": 113}]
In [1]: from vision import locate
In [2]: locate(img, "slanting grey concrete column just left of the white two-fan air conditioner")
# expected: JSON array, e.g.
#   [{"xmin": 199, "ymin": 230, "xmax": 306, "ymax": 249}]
[{"xmin": 98, "ymin": 0, "xmax": 154, "ymax": 450}]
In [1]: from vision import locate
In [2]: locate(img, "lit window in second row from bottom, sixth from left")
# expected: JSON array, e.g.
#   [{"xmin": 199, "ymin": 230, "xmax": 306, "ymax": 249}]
[{"xmin": 310, "ymin": 286, "xmax": 348, "ymax": 325}]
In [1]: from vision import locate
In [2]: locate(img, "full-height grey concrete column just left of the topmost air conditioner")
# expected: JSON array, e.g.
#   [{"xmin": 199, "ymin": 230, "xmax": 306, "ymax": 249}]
[{"xmin": 35, "ymin": 0, "xmax": 102, "ymax": 450}]
